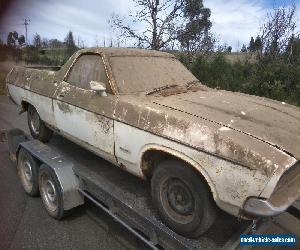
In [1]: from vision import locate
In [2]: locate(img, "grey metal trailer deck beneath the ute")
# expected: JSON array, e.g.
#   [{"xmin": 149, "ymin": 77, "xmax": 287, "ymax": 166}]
[{"xmin": 4, "ymin": 129, "xmax": 298, "ymax": 249}]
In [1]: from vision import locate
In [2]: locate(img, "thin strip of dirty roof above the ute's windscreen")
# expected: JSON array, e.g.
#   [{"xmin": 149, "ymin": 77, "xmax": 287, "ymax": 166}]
[{"xmin": 79, "ymin": 48, "xmax": 174, "ymax": 57}]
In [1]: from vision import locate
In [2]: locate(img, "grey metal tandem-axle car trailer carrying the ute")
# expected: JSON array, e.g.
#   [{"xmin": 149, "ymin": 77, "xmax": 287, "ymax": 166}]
[{"xmin": 2, "ymin": 129, "xmax": 299, "ymax": 249}]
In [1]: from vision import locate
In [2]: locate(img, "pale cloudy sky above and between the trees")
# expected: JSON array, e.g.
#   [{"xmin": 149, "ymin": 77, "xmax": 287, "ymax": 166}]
[{"xmin": 0, "ymin": 0, "xmax": 300, "ymax": 50}]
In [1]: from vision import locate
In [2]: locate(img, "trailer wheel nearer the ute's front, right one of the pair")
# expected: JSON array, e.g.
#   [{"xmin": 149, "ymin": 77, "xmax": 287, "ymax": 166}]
[{"xmin": 39, "ymin": 165, "xmax": 65, "ymax": 220}]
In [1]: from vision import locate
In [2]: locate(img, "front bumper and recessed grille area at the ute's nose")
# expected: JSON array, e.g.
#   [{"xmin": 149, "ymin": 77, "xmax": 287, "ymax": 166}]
[{"xmin": 242, "ymin": 164, "xmax": 300, "ymax": 217}]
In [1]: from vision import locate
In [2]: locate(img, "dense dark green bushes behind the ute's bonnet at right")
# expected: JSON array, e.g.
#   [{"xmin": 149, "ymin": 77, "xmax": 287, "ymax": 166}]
[{"xmin": 178, "ymin": 53, "xmax": 300, "ymax": 106}]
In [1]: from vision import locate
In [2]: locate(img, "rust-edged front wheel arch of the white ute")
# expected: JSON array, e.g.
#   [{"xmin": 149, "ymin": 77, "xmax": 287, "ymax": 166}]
[{"xmin": 139, "ymin": 144, "xmax": 219, "ymax": 203}]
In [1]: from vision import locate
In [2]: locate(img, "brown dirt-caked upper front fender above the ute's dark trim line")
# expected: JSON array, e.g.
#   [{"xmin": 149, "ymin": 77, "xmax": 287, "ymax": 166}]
[{"xmin": 115, "ymin": 96, "xmax": 290, "ymax": 177}]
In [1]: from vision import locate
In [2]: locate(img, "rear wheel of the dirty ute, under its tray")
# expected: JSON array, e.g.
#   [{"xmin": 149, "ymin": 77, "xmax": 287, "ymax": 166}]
[{"xmin": 27, "ymin": 105, "xmax": 53, "ymax": 142}]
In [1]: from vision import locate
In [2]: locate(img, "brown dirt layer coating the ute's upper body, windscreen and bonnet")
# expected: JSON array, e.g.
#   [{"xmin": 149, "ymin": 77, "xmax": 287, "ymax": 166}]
[{"xmin": 8, "ymin": 48, "xmax": 300, "ymax": 176}]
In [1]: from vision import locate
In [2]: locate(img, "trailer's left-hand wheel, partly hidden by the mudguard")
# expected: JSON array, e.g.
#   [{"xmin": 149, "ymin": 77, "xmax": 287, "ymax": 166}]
[{"xmin": 17, "ymin": 148, "xmax": 39, "ymax": 196}]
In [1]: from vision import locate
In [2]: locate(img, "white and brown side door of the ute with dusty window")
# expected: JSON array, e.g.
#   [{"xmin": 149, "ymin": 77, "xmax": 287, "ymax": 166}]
[{"xmin": 53, "ymin": 54, "xmax": 116, "ymax": 162}]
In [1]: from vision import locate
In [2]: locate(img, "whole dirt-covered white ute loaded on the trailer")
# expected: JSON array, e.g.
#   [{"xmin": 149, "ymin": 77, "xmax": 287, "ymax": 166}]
[{"xmin": 6, "ymin": 48, "xmax": 300, "ymax": 237}]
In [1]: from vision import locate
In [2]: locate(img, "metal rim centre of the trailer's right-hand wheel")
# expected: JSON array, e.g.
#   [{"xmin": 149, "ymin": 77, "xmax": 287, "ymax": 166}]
[{"xmin": 40, "ymin": 174, "xmax": 58, "ymax": 211}]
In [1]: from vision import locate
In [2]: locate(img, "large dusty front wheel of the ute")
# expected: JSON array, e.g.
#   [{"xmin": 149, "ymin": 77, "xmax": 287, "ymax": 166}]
[{"xmin": 151, "ymin": 160, "xmax": 217, "ymax": 238}]
